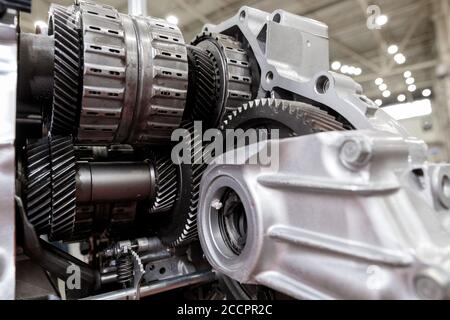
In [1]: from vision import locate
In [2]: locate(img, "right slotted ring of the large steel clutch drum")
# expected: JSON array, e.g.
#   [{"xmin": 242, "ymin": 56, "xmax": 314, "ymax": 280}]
[{"xmin": 127, "ymin": 17, "xmax": 188, "ymax": 144}]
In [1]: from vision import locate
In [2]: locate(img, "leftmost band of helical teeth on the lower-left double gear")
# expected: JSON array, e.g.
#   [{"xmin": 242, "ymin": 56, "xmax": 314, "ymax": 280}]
[{"xmin": 26, "ymin": 138, "xmax": 52, "ymax": 234}]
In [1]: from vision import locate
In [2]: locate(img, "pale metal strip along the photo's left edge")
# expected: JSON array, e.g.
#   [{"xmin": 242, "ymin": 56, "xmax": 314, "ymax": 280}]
[{"xmin": 0, "ymin": 11, "xmax": 17, "ymax": 299}]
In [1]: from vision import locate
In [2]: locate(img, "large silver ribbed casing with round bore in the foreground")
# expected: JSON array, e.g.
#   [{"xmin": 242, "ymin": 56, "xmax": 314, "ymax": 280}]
[{"xmin": 198, "ymin": 131, "xmax": 450, "ymax": 299}]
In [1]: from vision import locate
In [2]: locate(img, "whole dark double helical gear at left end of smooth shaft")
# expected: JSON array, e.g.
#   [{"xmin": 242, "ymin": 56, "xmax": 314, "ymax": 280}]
[{"xmin": 26, "ymin": 136, "xmax": 76, "ymax": 241}]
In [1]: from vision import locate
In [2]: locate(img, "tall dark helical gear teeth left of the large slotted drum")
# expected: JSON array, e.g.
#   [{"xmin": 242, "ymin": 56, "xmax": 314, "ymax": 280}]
[{"xmin": 49, "ymin": 4, "xmax": 82, "ymax": 135}]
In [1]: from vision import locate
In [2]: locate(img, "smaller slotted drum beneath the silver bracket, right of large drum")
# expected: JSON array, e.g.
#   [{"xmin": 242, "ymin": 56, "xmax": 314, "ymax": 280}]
[{"xmin": 192, "ymin": 32, "xmax": 253, "ymax": 126}]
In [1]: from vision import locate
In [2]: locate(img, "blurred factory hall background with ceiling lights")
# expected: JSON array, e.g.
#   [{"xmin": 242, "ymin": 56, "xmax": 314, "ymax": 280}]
[{"xmin": 21, "ymin": 0, "xmax": 450, "ymax": 161}]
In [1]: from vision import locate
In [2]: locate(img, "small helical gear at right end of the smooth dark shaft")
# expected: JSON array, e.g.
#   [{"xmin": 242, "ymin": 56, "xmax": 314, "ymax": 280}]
[{"xmin": 150, "ymin": 156, "xmax": 178, "ymax": 213}]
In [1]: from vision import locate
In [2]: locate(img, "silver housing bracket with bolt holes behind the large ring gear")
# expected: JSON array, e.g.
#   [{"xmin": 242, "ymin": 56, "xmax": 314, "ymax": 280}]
[{"xmin": 203, "ymin": 6, "xmax": 414, "ymax": 137}]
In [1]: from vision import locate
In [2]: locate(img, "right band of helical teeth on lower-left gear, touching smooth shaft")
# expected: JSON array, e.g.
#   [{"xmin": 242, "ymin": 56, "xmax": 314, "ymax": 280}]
[{"xmin": 50, "ymin": 137, "xmax": 76, "ymax": 240}]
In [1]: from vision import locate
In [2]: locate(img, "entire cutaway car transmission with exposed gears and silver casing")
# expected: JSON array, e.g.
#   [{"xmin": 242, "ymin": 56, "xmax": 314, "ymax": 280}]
[{"xmin": 0, "ymin": 0, "xmax": 450, "ymax": 300}]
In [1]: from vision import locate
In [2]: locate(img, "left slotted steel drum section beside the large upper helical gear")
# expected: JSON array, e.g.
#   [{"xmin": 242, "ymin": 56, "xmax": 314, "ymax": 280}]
[{"xmin": 77, "ymin": 1, "xmax": 129, "ymax": 143}]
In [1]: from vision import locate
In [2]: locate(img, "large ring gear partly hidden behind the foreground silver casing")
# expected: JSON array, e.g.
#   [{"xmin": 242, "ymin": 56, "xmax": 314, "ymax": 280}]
[{"xmin": 163, "ymin": 99, "xmax": 343, "ymax": 246}]
